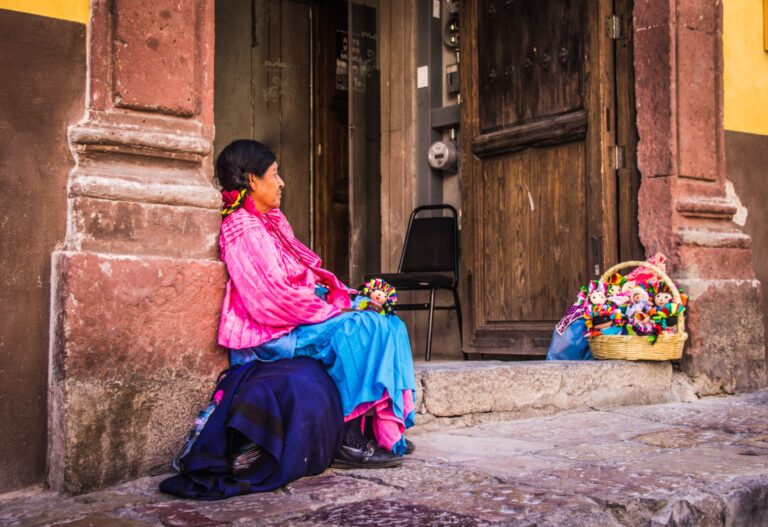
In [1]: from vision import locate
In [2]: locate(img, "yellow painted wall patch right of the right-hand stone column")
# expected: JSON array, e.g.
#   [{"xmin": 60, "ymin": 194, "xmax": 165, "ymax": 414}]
[{"xmin": 723, "ymin": 0, "xmax": 768, "ymax": 135}]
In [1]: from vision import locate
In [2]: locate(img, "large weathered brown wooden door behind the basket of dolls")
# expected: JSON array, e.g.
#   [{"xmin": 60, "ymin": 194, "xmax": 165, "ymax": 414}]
[{"xmin": 461, "ymin": 0, "xmax": 616, "ymax": 356}]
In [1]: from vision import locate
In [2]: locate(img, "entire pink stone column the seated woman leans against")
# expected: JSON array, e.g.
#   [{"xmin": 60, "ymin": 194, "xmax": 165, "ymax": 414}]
[{"xmin": 48, "ymin": 0, "xmax": 225, "ymax": 492}]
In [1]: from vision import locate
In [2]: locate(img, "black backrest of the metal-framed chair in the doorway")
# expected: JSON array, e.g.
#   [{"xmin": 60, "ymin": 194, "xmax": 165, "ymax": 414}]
[{"xmin": 398, "ymin": 205, "xmax": 459, "ymax": 280}]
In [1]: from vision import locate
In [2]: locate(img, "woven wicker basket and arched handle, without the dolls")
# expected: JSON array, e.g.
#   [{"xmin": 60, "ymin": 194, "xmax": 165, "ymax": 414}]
[{"xmin": 589, "ymin": 261, "xmax": 688, "ymax": 360}]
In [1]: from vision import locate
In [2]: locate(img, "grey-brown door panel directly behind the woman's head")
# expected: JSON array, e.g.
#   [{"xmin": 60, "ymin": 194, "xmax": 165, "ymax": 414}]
[{"xmin": 214, "ymin": 0, "xmax": 312, "ymax": 244}]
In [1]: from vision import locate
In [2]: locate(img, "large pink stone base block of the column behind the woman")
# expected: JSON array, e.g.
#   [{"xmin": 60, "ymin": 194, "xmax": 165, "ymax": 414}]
[{"xmin": 48, "ymin": 252, "xmax": 227, "ymax": 492}]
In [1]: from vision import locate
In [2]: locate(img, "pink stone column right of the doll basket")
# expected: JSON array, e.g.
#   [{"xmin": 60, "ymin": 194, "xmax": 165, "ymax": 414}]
[{"xmin": 634, "ymin": 0, "xmax": 766, "ymax": 393}]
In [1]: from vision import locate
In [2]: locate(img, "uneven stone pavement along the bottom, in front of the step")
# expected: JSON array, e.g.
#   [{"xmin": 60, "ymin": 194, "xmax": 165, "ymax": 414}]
[{"xmin": 0, "ymin": 392, "xmax": 768, "ymax": 527}]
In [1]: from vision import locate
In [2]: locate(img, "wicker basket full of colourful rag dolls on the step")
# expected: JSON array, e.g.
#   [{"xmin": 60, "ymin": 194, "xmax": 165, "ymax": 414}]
[{"xmin": 580, "ymin": 255, "xmax": 688, "ymax": 360}]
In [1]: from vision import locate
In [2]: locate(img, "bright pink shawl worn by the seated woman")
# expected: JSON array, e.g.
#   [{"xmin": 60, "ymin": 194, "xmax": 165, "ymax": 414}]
[{"xmin": 218, "ymin": 198, "xmax": 352, "ymax": 349}]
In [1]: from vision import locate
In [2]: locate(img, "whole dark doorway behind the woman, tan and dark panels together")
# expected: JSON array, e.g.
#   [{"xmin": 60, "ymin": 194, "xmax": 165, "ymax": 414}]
[{"xmin": 214, "ymin": 0, "xmax": 381, "ymax": 285}]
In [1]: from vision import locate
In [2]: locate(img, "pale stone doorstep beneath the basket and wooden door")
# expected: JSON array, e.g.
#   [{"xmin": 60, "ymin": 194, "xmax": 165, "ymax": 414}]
[{"xmin": 415, "ymin": 360, "xmax": 697, "ymax": 431}]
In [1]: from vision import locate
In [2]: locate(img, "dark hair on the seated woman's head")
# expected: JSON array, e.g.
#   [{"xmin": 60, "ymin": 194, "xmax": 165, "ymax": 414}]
[{"xmin": 216, "ymin": 139, "xmax": 277, "ymax": 190}]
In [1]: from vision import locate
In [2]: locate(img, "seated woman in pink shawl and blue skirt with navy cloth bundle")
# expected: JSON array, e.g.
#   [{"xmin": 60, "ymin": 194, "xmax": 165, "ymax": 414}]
[{"xmin": 161, "ymin": 140, "xmax": 415, "ymax": 499}]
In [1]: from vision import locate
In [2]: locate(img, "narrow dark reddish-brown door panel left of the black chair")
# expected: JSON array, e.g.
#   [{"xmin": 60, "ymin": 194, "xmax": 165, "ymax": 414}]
[{"xmin": 313, "ymin": 0, "xmax": 381, "ymax": 285}]
